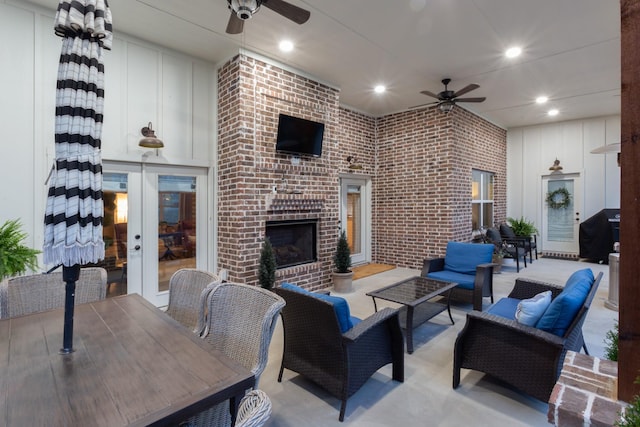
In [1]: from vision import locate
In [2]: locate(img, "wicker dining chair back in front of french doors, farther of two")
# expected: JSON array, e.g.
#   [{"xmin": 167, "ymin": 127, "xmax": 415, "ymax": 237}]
[{"xmin": 167, "ymin": 268, "xmax": 220, "ymax": 335}]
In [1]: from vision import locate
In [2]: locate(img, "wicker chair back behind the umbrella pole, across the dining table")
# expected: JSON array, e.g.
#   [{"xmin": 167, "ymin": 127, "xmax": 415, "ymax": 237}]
[{"xmin": 0, "ymin": 267, "xmax": 107, "ymax": 319}]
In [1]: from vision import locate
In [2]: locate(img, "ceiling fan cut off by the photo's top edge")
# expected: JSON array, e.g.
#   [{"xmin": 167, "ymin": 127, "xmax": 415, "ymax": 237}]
[{"xmin": 227, "ymin": 0, "xmax": 311, "ymax": 34}]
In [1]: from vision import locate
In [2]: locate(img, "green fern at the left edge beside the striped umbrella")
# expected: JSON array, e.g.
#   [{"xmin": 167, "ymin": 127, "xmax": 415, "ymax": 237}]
[{"xmin": 0, "ymin": 219, "xmax": 40, "ymax": 280}]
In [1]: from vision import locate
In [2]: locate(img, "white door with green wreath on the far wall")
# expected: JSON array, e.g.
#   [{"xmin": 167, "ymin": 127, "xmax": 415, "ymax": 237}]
[{"xmin": 541, "ymin": 173, "xmax": 583, "ymax": 254}]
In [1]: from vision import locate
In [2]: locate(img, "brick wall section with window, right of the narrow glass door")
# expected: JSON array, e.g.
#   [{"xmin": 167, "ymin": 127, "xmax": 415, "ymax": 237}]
[{"xmin": 373, "ymin": 107, "xmax": 506, "ymax": 268}]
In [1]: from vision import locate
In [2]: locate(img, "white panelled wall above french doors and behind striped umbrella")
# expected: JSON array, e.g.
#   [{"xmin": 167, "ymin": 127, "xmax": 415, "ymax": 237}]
[{"xmin": 0, "ymin": 2, "xmax": 216, "ymax": 266}]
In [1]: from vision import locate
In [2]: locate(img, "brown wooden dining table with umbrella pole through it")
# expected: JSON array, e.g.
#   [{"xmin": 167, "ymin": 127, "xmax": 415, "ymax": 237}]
[{"xmin": 0, "ymin": 294, "xmax": 255, "ymax": 427}]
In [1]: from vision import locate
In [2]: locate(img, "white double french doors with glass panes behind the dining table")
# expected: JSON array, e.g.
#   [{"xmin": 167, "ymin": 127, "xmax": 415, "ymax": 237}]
[{"xmin": 103, "ymin": 162, "xmax": 208, "ymax": 306}]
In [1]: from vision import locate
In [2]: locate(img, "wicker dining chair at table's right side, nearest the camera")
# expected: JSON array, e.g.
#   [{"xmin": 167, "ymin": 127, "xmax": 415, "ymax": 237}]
[{"xmin": 188, "ymin": 283, "xmax": 285, "ymax": 427}]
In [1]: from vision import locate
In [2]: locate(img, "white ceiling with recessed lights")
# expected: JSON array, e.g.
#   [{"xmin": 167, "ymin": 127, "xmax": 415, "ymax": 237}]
[{"xmin": 22, "ymin": 0, "xmax": 620, "ymax": 128}]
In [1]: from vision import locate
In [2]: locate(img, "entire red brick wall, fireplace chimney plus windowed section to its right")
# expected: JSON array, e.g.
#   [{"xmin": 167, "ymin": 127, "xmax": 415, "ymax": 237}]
[{"xmin": 217, "ymin": 55, "xmax": 506, "ymax": 289}]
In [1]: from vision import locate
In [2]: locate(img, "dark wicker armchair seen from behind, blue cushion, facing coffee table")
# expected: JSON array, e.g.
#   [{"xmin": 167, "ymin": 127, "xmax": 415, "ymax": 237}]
[{"xmin": 274, "ymin": 288, "xmax": 404, "ymax": 421}]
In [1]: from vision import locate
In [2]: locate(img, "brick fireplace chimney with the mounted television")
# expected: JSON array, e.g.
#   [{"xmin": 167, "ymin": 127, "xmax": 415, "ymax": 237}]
[{"xmin": 217, "ymin": 55, "xmax": 340, "ymax": 288}]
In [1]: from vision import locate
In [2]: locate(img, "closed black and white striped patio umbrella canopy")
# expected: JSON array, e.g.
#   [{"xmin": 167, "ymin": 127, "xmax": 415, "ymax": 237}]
[{"xmin": 43, "ymin": 0, "xmax": 112, "ymax": 266}]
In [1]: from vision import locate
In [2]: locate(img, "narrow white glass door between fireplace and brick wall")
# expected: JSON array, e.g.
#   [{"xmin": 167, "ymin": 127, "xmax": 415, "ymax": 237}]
[{"xmin": 340, "ymin": 177, "xmax": 371, "ymax": 264}]
